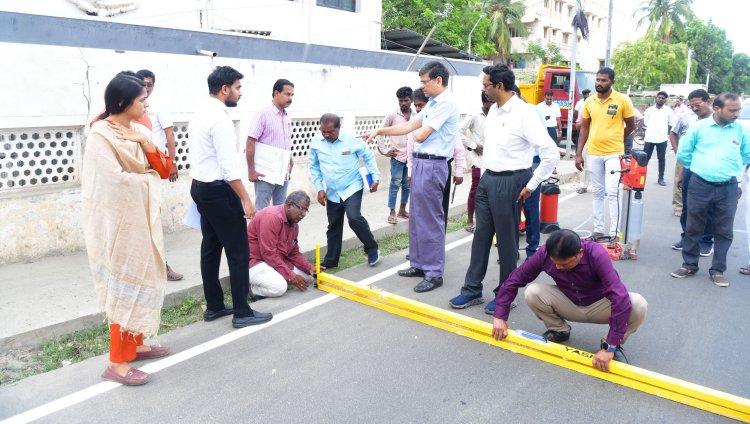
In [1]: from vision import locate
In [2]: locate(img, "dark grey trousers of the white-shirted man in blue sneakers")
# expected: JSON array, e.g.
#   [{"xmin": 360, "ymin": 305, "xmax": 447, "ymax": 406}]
[{"xmin": 461, "ymin": 169, "xmax": 531, "ymax": 296}]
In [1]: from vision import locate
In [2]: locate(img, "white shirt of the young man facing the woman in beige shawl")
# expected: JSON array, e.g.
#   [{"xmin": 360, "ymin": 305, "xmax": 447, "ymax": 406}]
[{"xmin": 188, "ymin": 97, "xmax": 242, "ymax": 183}]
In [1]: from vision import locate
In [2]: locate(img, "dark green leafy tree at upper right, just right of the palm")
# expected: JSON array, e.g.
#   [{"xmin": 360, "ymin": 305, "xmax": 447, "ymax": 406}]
[{"xmin": 682, "ymin": 20, "xmax": 734, "ymax": 93}]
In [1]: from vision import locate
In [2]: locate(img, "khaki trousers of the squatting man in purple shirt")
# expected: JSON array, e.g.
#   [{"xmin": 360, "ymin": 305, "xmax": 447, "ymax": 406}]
[{"xmin": 524, "ymin": 283, "xmax": 648, "ymax": 343}]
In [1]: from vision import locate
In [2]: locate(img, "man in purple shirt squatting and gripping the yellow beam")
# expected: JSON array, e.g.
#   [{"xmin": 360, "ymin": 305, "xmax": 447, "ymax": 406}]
[{"xmin": 492, "ymin": 230, "xmax": 648, "ymax": 371}]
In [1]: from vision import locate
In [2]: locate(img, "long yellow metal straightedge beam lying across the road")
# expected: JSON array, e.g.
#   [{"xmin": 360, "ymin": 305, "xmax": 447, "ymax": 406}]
[{"xmin": 315, "ymin": 246, "xmax": 750, "ymax": 422}]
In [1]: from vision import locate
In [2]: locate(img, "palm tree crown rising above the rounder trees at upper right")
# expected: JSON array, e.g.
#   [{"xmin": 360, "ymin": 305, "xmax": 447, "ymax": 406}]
[{"xmin": 633, "ymin": 0, "xmax": 694, "ymax": 43}]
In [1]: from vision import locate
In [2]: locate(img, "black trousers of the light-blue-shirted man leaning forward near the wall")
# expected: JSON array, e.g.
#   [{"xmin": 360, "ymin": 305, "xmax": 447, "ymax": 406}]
[{"xmin": 323, "ymin": 190, "xmax": 378, "ymax": 268}]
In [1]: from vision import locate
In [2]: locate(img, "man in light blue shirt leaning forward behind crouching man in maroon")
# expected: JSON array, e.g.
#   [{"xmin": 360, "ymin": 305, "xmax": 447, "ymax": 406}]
[{"xmin": 309, "ymin": 113, "xmax": 380, "ymax": 268}]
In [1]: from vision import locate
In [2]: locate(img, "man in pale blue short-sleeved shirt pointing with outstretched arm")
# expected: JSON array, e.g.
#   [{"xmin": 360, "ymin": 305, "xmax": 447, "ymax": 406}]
[{"xmin": 362, "ymin": 61, "xmax": 459, "ymax": 293}]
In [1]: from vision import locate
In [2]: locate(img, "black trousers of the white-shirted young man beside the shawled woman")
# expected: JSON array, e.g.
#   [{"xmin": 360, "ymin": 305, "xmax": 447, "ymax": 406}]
[{"xmin": 190, "ymin": 180, "xmax": 253, "ymax": 318}]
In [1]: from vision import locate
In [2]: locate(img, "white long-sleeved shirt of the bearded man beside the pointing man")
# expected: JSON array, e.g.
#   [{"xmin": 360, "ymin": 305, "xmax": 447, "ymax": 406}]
[{"xmin": 482, "ymin": 95, "xmax": 560, "ymax": 191}]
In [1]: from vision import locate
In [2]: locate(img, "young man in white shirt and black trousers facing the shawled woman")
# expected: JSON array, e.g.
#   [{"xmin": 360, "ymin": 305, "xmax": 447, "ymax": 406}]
[{"xmin": 188, "ymin": 66, "xmax": 272, "ymax": 328}]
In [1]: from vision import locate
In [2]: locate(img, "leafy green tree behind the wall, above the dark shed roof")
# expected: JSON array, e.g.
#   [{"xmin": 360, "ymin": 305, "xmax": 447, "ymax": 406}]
[{"xmin": 382, "ymin": 0, "xmax": 497, "ymax": 57}]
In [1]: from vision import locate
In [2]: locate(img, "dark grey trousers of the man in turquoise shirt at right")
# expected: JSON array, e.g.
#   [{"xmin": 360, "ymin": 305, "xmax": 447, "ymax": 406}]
[{"xmin": 682, "ymin": 174, "xmax": 739, "ymax": 272}]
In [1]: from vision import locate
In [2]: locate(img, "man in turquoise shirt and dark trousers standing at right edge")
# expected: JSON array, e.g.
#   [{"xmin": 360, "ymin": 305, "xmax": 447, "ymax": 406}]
[{"xmin": 672, "ymin": 93, "xmax": 750, "ymax": 287}]
